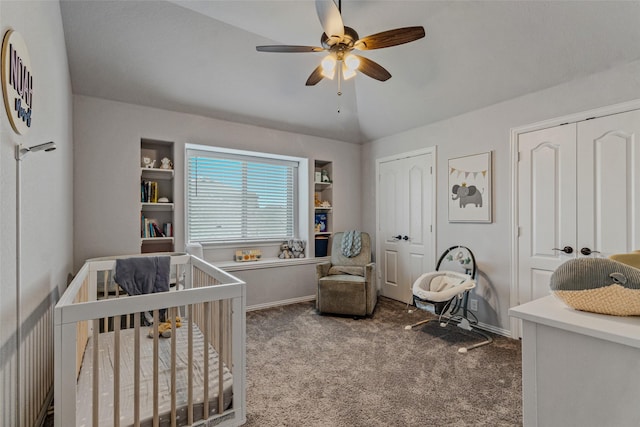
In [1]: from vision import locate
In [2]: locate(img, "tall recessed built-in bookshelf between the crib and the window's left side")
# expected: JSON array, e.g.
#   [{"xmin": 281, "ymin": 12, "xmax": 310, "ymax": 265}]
[{"xmin": 140, "ymin": 139, "xmax": 175, "ymax": 253}]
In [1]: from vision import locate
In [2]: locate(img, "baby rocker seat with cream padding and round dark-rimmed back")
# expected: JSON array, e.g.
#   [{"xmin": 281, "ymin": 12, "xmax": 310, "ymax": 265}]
[{"xmin": 405, "ymin": 246, "xmax": 493, "ymax": 353}]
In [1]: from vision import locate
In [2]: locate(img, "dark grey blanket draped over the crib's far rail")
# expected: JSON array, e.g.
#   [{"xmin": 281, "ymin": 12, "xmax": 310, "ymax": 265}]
[{"xmin": 114, "ymin": 256, "xmax": 171, "ymax": 295}]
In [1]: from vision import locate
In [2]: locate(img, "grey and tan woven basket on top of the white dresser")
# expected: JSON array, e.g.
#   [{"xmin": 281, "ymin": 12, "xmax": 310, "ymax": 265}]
[{"xmin": 550, "ymin": 252, "xmax": 640, "ymax": 316}]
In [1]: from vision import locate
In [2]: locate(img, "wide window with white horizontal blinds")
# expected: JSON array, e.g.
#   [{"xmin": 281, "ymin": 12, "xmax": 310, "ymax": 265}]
[{"xmin": 186, "ymin": 145, "xmax": 299, "ymax": 243}]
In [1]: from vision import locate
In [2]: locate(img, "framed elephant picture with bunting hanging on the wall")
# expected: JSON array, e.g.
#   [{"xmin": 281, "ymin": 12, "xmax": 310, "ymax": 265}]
[{"xmin": 447, "ymin": 151, "xmax": 493, "ymax": 222}]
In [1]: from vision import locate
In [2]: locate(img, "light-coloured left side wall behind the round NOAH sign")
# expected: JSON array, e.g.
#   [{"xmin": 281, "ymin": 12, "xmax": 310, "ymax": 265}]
[{"xmin": 0, "ymin": 0, "xmax": 73, "ymax": 426}]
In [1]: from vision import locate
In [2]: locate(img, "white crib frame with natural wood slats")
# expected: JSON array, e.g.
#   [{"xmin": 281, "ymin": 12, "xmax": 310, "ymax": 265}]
[{"xmin": 55, "ymin": 255, "xmax": 246, "ymax": 426}]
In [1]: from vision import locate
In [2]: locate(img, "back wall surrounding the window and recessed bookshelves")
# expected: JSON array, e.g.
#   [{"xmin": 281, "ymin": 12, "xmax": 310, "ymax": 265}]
[{"xmin": 73, "ymin": 96, "xmax": 362, "ymax": 306}]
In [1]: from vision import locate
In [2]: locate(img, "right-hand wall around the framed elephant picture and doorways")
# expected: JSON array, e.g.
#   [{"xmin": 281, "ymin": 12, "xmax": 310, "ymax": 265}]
[{"xmin": 362, "ymin": 61, "xmax": 640, "ymax": 331}]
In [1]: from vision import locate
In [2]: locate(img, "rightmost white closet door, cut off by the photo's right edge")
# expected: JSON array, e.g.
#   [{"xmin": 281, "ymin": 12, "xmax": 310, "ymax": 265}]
[{"xmin": 577, "ymin": 111, "xmax": 640, "ymax": 256}]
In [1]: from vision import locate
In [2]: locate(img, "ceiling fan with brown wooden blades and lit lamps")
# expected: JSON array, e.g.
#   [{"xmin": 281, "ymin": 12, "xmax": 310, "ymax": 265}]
[{"xmin": 256, "ymin": 0, "xmax": 425, "ymax": 86}]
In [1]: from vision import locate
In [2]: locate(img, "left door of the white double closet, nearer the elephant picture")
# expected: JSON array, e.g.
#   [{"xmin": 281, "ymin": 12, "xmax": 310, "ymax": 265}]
[{"xmin": 518, "ymin": 124, "xmax": 577, "ymax": 304}]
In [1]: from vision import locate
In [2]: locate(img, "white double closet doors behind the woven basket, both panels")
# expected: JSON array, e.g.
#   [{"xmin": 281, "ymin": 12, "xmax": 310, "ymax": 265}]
[{"xmin": 517, "ymin": 110, "xmax": 640, "ymax": 304}]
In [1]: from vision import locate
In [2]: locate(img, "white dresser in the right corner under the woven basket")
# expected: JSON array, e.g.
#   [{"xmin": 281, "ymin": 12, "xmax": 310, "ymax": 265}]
[{"xmin": 509, "ymin": 295, "xmax": 640, "ymax": 427}]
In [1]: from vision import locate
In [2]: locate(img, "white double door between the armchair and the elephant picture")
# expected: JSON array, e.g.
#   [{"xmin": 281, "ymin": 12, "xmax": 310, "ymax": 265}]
[{"xmin": 376, "ymin": 154, "xmax": 434, "ymax": 302}]
